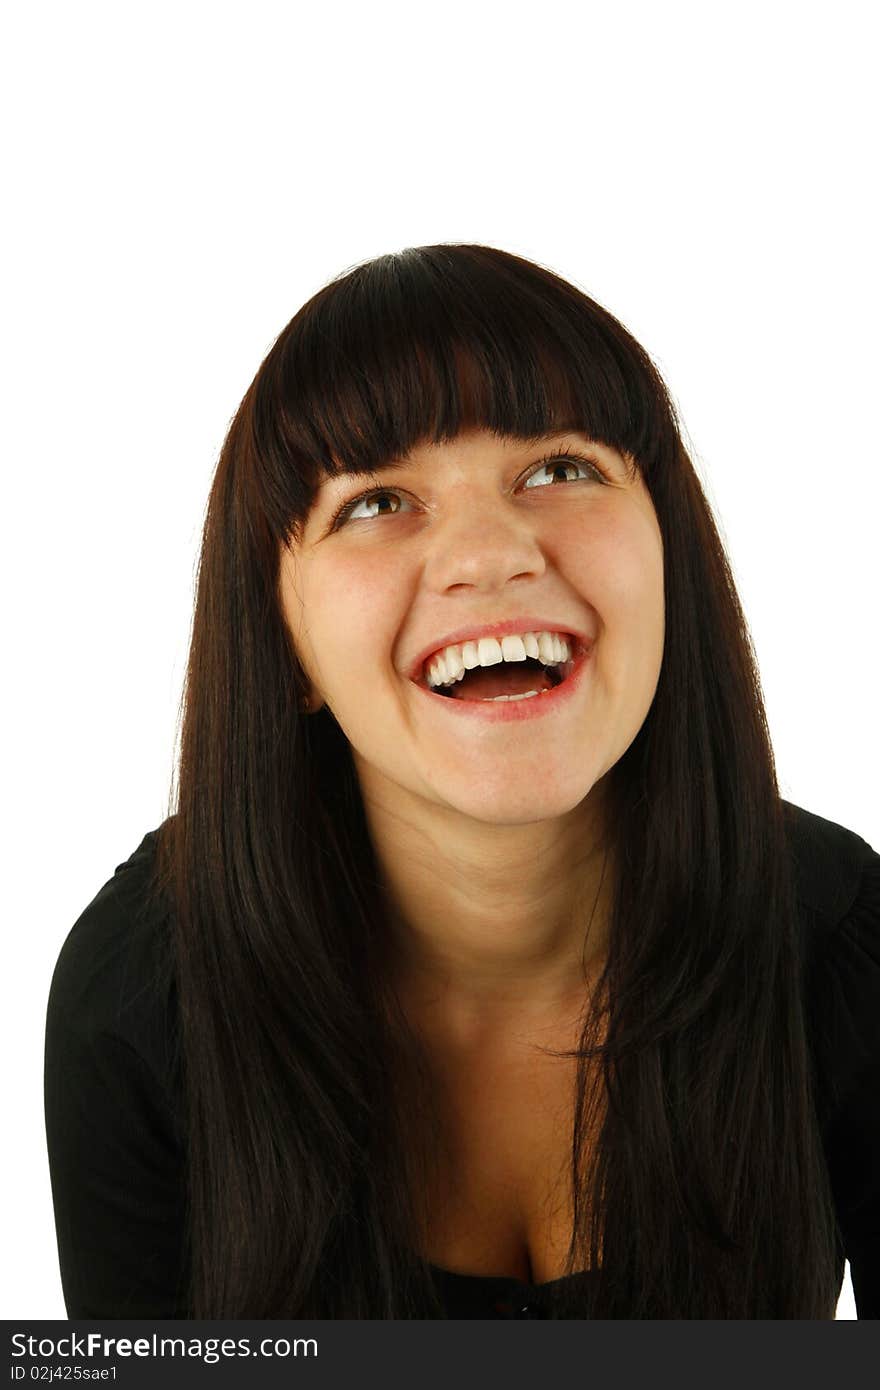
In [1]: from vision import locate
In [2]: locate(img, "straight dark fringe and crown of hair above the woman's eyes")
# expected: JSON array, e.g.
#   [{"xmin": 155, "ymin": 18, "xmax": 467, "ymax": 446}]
[{"xmin": 254, "ymin": 245, "xmax": 671, "ymax": 532}]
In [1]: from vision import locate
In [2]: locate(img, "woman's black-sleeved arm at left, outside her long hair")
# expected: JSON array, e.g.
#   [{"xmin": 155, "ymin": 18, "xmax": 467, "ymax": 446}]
[{"xmin": 44, "ymin": 861, "xmax": 189, "ymax": 1318}]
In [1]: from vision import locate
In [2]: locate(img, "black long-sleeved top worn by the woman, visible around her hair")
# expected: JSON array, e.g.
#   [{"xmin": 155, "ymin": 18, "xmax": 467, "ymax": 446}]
[{"xmin": 44, "ymin": 803, "xmax": 880, "ymax": 1319}]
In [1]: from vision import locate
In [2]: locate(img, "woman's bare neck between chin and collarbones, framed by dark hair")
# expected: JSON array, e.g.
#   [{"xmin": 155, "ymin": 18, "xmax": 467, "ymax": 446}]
[{"xmin": 364, "ymin": 798, "xmax": 612, "ymax": 1030}]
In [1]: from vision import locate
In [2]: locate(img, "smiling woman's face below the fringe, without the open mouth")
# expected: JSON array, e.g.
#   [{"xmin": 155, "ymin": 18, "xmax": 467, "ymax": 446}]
[{"xmin": 281, "ymin": 430, "xmax": 665, "ymax": 824}]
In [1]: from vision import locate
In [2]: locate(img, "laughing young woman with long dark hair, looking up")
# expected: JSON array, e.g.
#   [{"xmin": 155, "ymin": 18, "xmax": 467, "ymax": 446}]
[{"xmin": 46, "ymin": 245, "xmax": 880, "ymax": 1319}]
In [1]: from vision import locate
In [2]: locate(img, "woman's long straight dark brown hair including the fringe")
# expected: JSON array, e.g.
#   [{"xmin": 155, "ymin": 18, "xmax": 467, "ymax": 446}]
[{"xmin": 147, "ymin": 245, "xmax": 842, "ymax": 1318}]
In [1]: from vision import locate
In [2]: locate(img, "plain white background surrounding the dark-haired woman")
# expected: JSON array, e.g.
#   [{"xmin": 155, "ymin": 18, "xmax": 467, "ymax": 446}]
[{"xmin": 0, "ymin": 0, "xmax": 880, "ymax": 1318}]
